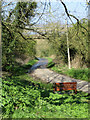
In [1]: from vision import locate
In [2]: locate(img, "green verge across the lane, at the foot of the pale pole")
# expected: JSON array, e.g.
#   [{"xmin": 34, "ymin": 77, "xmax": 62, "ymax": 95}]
[{"xmin": 51, "ymin": 66, "xmax": 90, "ymax": 82}]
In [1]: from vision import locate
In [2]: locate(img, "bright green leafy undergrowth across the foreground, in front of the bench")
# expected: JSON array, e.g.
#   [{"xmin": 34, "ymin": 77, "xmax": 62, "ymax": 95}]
[{"xmin": 2, "ymin": 61, "xmax": 89, "ymax": 118}]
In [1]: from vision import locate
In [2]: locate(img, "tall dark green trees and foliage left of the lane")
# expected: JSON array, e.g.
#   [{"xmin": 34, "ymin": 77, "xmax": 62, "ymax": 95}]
[{"xmin": 2, "ymin": 1, "xmax": 37, "ymax": 72}]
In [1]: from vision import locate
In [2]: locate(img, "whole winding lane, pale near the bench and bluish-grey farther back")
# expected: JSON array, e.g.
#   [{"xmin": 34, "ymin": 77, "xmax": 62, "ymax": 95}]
[{"xmin": 28, "ymin": 58, "xmax": 90, "ymax": 93}]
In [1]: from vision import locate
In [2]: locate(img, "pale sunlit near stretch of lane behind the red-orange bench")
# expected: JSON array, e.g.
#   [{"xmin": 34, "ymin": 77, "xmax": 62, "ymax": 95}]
[{"xmin": 30, "ymin": 68, "xmax": 90, "ymax": 93}]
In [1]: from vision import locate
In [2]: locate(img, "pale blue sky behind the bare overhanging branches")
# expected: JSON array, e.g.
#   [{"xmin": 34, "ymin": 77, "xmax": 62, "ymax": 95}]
[{"xmin": 4, "ymin": 0, "xmax": 89, "ymax": 24}]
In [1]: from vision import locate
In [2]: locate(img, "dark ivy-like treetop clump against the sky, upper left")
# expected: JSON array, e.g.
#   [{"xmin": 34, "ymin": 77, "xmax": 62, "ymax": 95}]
[{"xmin": 14, "ymin": 1, "xmax": 37, "ymax": 27}]
